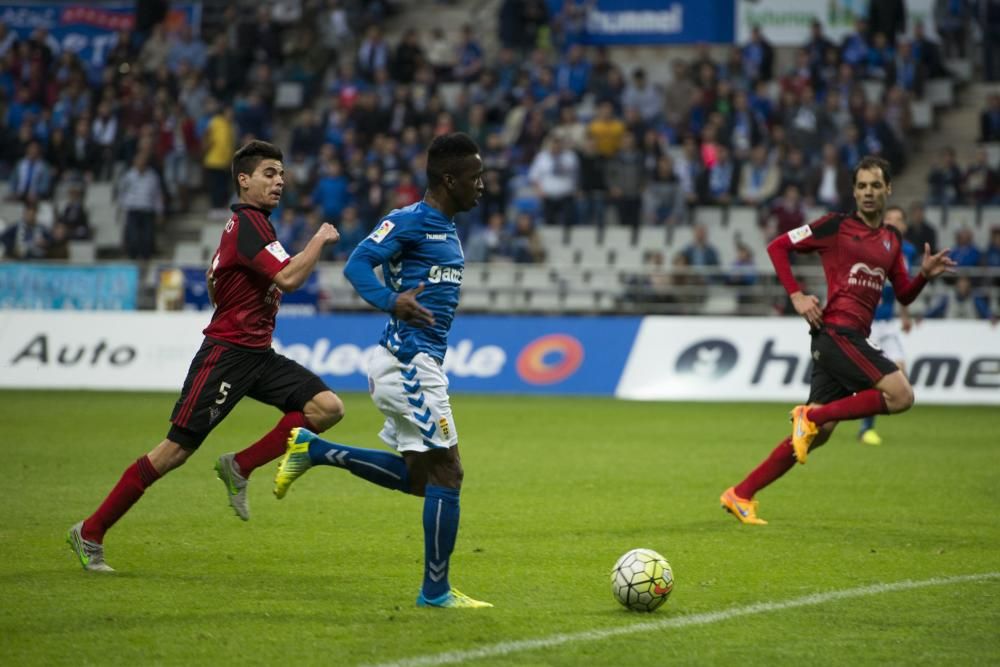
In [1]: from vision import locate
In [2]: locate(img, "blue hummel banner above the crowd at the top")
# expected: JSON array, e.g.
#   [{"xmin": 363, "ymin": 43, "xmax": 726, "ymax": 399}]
[{"xmin": 564, "ymin": 0, "xmax": 736, "ymax": 45}]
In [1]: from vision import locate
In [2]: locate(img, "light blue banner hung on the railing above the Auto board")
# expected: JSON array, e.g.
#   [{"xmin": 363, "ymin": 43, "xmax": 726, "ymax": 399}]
[{"xmin": 0, "ymin": 264, "xmax": 139, "ymax": 310}]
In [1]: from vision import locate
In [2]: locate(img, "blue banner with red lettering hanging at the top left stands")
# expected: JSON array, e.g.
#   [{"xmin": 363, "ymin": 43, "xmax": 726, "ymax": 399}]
[{"xmin": 0, "ymin": 2, "xmax": 201, "ymax": 70}]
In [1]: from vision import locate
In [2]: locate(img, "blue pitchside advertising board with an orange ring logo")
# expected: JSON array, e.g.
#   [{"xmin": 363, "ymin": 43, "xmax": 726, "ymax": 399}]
[{"xmin": 274, "ymin": 314, "xmax": 642, "ymax": 396}]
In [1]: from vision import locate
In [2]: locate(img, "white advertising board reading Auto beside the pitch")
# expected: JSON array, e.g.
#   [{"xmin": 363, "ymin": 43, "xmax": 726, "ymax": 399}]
[{"xmin": 0, "ymin": 310, "xmax": 211, "ymax": 391}]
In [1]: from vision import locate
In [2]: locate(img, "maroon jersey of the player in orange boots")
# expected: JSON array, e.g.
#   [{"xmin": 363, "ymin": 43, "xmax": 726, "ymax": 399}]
[{"xmin": 767, "ymin": 213, "xmax": 926, "ymax": 336}]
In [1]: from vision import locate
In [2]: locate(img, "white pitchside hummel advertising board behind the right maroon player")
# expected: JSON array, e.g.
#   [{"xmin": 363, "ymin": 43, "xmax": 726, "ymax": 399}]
[{"xmin": 615, "ymin": 317, "xmax": 1000, "ymax": 405}]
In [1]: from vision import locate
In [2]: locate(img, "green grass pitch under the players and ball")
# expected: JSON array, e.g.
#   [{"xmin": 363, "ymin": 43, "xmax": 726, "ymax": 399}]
[{"xmin": 0, "ymin": 391, "xmax": 1000, "ymax": 666}]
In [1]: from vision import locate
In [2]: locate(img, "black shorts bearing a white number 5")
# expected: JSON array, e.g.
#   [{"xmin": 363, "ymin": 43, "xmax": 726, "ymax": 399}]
[{"xmin": 167, "ymin": 338, "xmax": 329, "ymax": 449}]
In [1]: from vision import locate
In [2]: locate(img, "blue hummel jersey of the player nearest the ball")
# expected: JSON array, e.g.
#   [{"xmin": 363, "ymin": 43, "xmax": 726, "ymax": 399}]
[{"xmin": 344, "ymin": 201, "xmax": 465, "ymax": 363}]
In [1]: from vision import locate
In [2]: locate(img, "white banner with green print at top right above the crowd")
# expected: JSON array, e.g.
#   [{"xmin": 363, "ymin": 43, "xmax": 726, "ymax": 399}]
[{"xmin": 736, "ymin": 0, "xmax": 938, "ymax": 46}]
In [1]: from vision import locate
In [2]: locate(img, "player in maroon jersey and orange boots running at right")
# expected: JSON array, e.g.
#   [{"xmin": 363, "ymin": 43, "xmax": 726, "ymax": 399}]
[{"xmin": 720, "ymin": 156, "xmax": 955, "ymax": 524}]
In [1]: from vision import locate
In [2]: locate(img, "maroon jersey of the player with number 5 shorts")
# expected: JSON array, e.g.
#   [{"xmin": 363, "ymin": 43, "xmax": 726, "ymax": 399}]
[{"xmin": 204, "ymin": 204, "xmax": 291, "ymax": 348}]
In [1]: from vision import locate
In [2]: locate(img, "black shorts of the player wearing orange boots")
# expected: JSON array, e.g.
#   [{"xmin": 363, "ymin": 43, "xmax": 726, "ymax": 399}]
[{"xmin": 808, "ymin": 326, "xmax": 899, "ymax": 403}]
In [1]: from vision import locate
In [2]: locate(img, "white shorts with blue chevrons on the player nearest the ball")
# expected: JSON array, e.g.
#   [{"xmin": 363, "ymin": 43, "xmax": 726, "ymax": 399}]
[{"xmin": 368, "ymin": 346, "xmax": 458, "ymax": 452}]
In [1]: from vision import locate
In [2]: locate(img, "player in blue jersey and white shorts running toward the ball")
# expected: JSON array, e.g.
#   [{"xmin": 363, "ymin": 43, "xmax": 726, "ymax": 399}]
[{"xmin": 274, "ymin": 133, "xmax": 493, "ymax": 608}]
